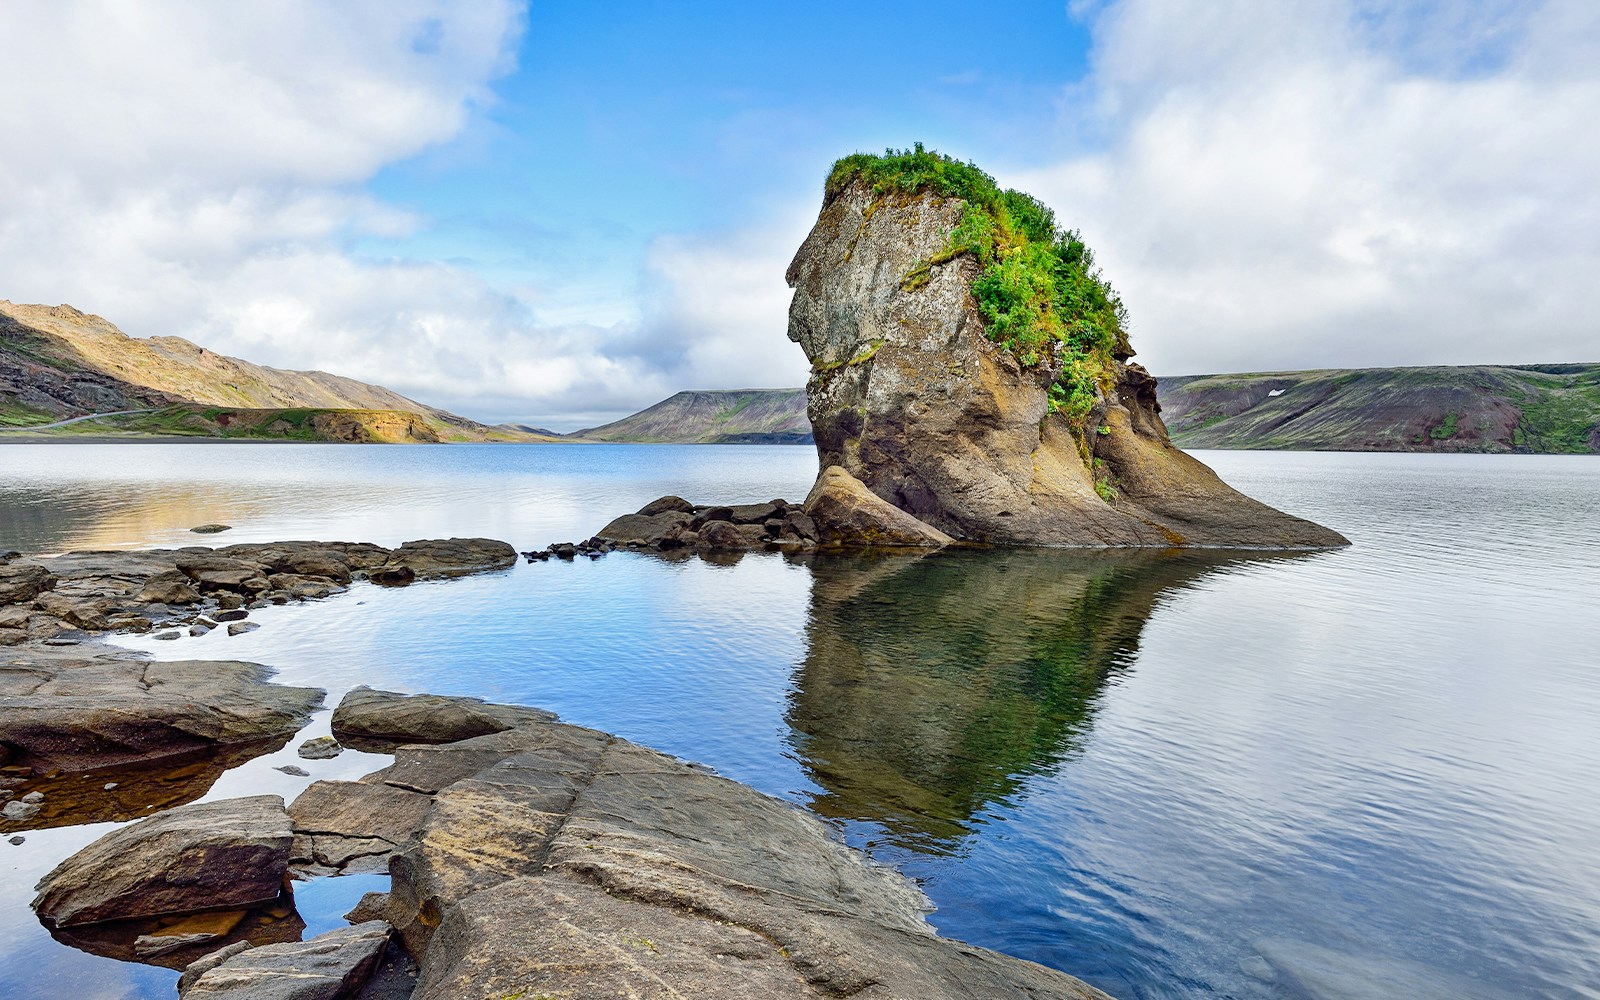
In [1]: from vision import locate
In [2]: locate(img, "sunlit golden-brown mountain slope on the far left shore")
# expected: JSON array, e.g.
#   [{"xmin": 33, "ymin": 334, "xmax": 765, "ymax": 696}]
[{"xmin": 0, "ymin": 299, "xmax": 550, "ymax": 442}]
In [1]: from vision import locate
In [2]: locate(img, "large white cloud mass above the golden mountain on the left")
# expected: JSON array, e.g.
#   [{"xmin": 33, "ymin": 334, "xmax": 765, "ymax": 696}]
[{"xmin": 0, "ymin": 0, "xmax": 566, "ymax": 405}]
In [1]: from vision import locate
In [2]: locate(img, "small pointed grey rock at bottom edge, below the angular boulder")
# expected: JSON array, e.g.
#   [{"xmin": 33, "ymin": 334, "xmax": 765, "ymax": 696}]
[{"xmin": 178, "ymin": 920, "xmax": 389, "ymax": 1000}]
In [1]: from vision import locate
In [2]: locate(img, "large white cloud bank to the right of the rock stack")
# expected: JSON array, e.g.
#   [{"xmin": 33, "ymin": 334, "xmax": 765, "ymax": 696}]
[{"xmin": 1005, "ymin": 0, "xmax": 1600, "ymax": 374}]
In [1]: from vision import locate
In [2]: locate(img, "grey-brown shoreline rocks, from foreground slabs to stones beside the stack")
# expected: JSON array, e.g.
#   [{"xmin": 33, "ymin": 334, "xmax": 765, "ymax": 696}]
[{"xmin": 0, "ymin": 540, "xmax": 1104, "ymax": 1000}]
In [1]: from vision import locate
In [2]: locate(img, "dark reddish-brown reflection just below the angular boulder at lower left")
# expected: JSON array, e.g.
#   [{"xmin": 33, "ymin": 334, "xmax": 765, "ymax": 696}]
[{"xmin": 48, "ymin": 890, "xmax": 306, "ymax": 970}]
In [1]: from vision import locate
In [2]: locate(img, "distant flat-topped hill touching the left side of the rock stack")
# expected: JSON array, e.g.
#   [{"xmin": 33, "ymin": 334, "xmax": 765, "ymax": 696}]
[{"xmin": 566, "ymin": 389, "xmax": 811, "ymax": 445}]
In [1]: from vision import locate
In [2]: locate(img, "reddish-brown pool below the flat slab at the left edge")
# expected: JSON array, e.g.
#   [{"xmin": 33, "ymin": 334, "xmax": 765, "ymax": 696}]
[{"xmin": 0, "ymin": 736, "xmax": 288, "ymax": 834}]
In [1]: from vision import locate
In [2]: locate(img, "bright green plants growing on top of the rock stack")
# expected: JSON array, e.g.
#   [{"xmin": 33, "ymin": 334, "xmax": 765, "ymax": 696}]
[{"xmin": 826, "ymin": 142, "xmax": 1133, "ymax": 429}]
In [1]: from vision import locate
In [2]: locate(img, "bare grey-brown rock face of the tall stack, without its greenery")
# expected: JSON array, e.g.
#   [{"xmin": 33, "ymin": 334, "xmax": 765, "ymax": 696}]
[{"xmin": 787, "ymin": 181, "xmax": 1347, "ymax": 549}]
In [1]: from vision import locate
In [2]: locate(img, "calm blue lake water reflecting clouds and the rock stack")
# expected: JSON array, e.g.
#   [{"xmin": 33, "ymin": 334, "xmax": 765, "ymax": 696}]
[{"xmin": 0, "ymin": 445, "xmax": 1600, "ymax": 1000}]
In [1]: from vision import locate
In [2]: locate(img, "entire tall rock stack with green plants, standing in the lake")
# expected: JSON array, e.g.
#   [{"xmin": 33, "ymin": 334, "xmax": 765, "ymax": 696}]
[{"xmin": 787, "ymin": 147, "xmax": 1347, "ymax": 549}]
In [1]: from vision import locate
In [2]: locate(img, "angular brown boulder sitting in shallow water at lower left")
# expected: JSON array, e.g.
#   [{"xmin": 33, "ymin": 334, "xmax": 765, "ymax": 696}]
[{"xmin": 34, "ymin": 795, "xmax": 293, "ymax": 926}]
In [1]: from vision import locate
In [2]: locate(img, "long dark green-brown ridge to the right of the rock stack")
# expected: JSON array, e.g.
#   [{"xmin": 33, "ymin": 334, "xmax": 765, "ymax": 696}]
[{"xmin": 1157, "ymin": 365, "xmax": 1600, "ymax": 454}]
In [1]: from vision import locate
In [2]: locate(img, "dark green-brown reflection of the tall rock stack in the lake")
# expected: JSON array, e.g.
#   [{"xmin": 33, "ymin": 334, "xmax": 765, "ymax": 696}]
[{"xmin": 787, "ymin": 550, "xmax": 1294, "ymax": 851}]
